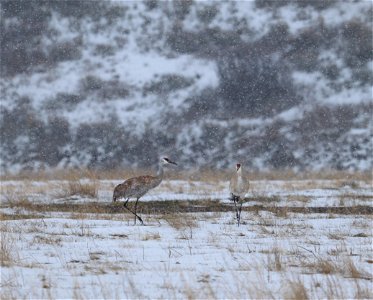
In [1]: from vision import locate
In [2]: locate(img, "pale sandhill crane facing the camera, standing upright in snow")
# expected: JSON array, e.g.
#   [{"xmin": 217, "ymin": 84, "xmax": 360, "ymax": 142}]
[{"xmin": 229, "ymin": 164, "xmax": 249, "ymax": 226}]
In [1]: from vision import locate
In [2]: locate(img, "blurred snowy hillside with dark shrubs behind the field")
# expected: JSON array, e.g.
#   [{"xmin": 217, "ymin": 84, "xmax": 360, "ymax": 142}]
[{"xmin": 0, "ymin": 0, "xmax": 373, "ymax": 171}]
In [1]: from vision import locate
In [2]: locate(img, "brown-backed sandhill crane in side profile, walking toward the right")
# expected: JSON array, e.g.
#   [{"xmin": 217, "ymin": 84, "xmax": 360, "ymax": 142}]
[{"xmin": 113, "ymin": 157, "xmax": 177, "ymax": 225}]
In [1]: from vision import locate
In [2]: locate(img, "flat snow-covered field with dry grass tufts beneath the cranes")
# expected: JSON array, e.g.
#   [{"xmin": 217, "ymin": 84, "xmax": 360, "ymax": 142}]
[{"xmin": 0, "ymin": 179, "xmax": 373, "ymax": 299}]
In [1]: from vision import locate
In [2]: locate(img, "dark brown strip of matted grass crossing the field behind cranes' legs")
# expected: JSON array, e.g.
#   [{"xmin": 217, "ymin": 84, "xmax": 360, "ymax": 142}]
[{"xmin": 0, "ymin": 199, "xmax": 373, "ymax": 219}]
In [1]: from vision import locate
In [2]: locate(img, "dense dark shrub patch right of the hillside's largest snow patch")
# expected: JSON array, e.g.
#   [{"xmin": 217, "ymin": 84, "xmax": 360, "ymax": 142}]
[{"xmin": 218, "ymin": 49, "xmax": 300, "ymax": 117}]
